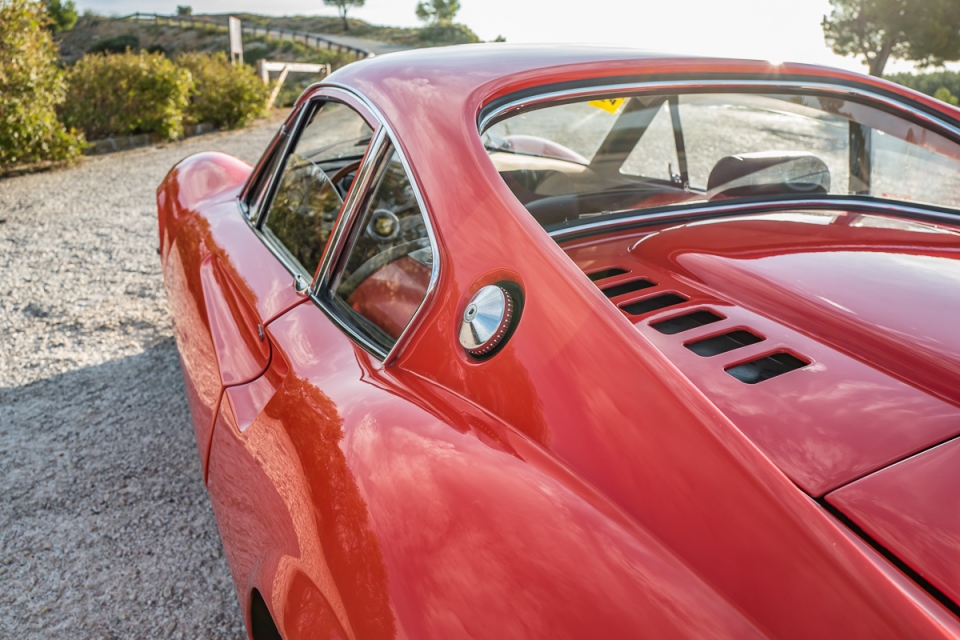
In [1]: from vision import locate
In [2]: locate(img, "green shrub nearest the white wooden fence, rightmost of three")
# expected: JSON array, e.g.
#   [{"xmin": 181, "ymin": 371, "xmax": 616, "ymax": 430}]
[{"xmin": 176, "ymin": 52, "xmax": 270, "ymax": 129}]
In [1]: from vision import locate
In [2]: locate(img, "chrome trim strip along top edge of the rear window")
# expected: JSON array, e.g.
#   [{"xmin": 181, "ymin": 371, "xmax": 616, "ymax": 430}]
[{"xmin": 477, "ymin": 78, "xmax": 960, "ymax": 143}]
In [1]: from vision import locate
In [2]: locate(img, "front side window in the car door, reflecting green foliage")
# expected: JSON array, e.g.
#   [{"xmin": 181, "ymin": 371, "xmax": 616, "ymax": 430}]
[{"xmin": 262, "ymin": 102, "xmax": 373, "ymax": 276}]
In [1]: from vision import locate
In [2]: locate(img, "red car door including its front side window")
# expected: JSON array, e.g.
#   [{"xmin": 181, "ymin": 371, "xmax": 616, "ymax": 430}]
[{"xmin": 164, "ymin": 90, "xmax": 376, "ymax": 470}]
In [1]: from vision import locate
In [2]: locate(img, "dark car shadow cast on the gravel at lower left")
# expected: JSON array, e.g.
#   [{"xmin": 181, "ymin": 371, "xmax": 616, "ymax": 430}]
[{"xmin": 0, "ymin": 338, "xmax": 244, "ymax": 638}]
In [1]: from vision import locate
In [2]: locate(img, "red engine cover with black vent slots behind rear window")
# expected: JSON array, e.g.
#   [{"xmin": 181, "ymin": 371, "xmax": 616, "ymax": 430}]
[{"xmin": 564, "ymin": 211, "xmax": 960, "ymax": 497}]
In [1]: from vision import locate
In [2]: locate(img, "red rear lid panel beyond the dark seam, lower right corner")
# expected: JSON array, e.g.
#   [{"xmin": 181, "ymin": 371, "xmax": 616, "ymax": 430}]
[{"xmin": 827, "ymin": 440, "xmax": 960, "ymax": 601}]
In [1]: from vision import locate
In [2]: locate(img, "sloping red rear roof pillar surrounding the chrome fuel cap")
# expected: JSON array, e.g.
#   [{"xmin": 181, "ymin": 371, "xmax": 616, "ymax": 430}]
[{"xmin": 346, "ymin": 62, "xmax": 958, "ymax": 638}]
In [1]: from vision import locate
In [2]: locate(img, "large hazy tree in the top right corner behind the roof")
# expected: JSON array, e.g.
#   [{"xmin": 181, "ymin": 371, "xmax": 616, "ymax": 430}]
[{"xmin": 822, "ymin": 0, "xmax": 960, "ymax": 76}]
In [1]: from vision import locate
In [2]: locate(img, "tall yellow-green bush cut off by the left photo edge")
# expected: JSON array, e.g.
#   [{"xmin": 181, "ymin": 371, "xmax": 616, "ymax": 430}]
[{"xmin": 0, "ymin": 0, "xmax": 83, "ymax": 167}]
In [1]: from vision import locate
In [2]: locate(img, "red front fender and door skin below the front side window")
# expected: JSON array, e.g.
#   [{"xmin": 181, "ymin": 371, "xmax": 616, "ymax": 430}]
[{"xmin": 158, "ymin": 154, "xmax": 303, "ymax": 468}]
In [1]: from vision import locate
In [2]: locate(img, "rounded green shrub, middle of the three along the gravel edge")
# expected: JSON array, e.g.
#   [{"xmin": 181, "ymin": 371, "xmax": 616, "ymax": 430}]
[{"xmin": 61, "ymin": 52, "xmax": 193, "ymax": 139}]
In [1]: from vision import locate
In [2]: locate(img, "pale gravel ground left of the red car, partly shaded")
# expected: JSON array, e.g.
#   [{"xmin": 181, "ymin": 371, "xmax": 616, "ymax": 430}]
[{"xmin": 0, "ymin": 119, "xmax": 279, "ymax": 638}]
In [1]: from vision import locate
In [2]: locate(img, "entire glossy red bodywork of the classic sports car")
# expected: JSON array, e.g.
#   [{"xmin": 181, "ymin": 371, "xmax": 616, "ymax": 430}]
[{"xmin": 158, "ymin": 46, "xmax": 960, "ymax": 639}]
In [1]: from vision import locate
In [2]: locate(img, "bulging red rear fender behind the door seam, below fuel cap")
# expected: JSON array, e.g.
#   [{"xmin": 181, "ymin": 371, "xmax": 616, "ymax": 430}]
[{"xmin": 210, "ymin": 304, "xmax": 762, "ymax": 638}]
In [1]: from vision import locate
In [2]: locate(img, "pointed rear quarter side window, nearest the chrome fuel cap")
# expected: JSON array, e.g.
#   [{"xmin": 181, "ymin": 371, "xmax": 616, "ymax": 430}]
[{"xmin": 333, "ymin": 151, "xmax": 434, "ymax": 351}]
